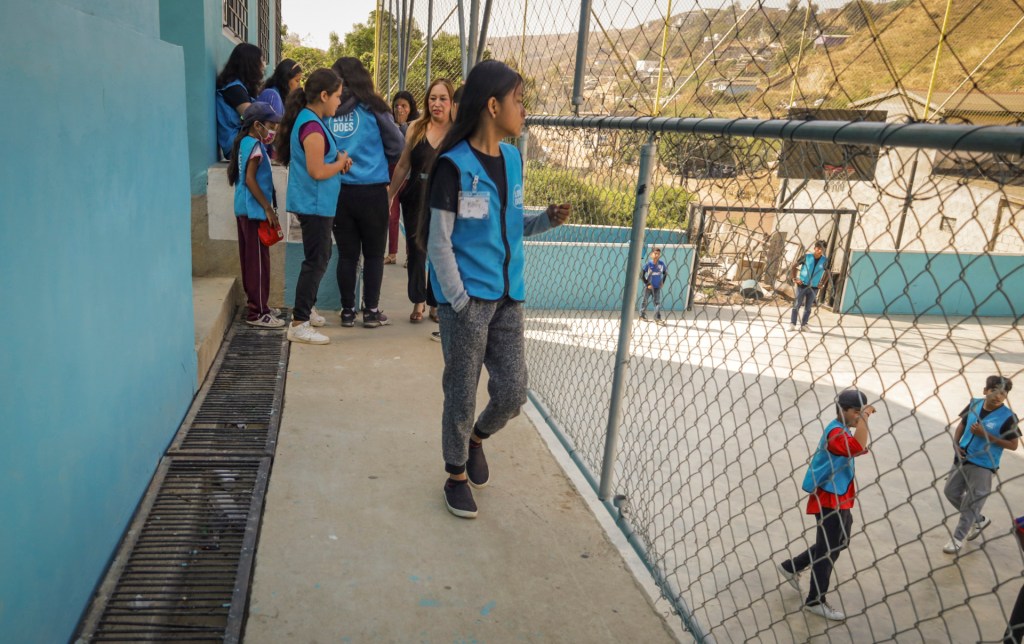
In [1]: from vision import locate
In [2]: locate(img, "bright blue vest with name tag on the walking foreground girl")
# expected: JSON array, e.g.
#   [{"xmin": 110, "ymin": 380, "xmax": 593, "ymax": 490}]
[{"xmin": 430, "ymin": 140, "xmax": 526, "ymax": 303}]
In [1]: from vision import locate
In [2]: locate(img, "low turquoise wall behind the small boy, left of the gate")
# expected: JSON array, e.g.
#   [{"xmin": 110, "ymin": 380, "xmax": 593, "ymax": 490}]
[{"xmin": 525, "ymin": 241, "xmax": 693, "ymax": 311}]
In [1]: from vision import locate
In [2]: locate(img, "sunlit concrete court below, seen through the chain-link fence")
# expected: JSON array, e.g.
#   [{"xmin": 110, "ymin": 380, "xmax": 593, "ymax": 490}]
[{"xmin": 526, "ymin": 306, "xmax": 1024, "ymax": 642}]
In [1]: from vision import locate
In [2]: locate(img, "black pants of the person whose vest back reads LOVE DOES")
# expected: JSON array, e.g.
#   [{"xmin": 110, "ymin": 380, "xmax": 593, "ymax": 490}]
[{"xmin": 334, "ymin": 183, "xmax": 388, "ymax": 309}]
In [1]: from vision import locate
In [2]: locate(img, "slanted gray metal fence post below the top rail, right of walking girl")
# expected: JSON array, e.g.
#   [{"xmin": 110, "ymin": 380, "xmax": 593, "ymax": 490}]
[{"xmin": 598, "ymin": 134, "xmax": 655, "ymax": 501}]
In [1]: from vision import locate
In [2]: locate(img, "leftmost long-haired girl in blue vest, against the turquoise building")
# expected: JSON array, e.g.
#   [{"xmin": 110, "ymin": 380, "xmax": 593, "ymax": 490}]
[{"xmin": 215, "ymin": 43, "xmax": 265, "ymax": 160}]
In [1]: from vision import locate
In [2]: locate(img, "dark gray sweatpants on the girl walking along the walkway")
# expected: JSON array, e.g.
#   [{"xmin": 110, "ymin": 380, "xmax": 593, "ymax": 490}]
[{"xmin": 437, "ymin": 299, "xmax": 526, "ymax": 474}]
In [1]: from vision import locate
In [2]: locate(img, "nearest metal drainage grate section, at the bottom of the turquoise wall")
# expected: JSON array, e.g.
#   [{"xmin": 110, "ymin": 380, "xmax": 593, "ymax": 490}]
[{"xmin": 79, "ymin": 458, "xmax": 270, "ymax": 642}]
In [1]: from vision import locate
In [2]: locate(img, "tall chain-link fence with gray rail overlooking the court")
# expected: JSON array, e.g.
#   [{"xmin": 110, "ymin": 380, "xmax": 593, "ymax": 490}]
[{"xmin": 372, "ymin": 0, "xmax": 1024, "ymax": 642}]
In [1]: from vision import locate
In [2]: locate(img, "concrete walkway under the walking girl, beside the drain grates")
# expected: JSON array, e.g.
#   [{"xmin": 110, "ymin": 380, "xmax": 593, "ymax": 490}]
[{"xmin": 245, "ymin": 264, "xmax": 678, "ymax": 644}]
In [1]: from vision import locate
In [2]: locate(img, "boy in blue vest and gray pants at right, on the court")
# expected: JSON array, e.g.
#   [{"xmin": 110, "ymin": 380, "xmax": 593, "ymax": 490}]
[{"xmin": 942, "ymin": 376, "xmax": 1021, "ymax": 555}]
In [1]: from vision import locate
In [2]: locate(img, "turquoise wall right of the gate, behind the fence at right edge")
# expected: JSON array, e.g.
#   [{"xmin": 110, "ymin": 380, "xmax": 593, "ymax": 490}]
[{"xmin": 842, "ymin": 251, "xmax": 1024, "ymax": 317}]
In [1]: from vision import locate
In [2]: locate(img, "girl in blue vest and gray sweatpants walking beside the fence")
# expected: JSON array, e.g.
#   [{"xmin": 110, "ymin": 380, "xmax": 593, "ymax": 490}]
[{"xmin": 417, "ymin": 60, "xmax": 570, "ymax": 519}]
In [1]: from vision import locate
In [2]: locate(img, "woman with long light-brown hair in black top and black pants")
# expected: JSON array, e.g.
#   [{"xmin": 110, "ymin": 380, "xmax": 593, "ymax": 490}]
[{"xmin": 387, "ymin": 78, "xmax": 454, "ymax": 323}]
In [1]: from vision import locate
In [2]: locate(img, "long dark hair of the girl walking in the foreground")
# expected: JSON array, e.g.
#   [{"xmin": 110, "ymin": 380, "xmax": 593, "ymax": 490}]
[{"xmin": 416, "ymin": 60, "xmax": 523, "ymax": 249}]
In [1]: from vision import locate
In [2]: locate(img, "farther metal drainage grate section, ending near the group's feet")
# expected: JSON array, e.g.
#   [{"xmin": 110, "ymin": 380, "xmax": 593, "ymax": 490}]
[{"xmin": 168, "ymin": 321, "xmax": 289, "ymax": 455}]
